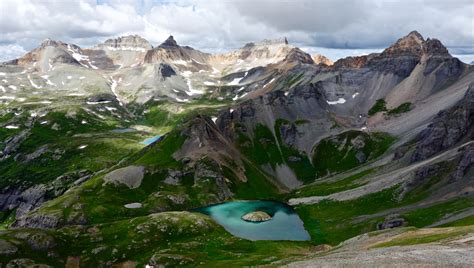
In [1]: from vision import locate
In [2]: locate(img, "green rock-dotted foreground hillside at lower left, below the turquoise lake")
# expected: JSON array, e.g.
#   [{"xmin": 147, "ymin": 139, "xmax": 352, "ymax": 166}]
[{"xmin": 0, "ymin": 212, "xmax": 311, "ymax": 267}]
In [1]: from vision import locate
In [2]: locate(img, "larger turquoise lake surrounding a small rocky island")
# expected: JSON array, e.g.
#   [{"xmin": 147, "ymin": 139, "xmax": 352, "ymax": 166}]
[{"xmin": 195, "ymin": 201, "xmax": 311, "ymax": 241}]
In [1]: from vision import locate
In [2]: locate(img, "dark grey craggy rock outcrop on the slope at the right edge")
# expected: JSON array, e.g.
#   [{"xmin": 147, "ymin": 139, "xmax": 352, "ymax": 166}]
[{"xmin": 411, "ymin": 83, "xmax": 474, "ymax": 162}]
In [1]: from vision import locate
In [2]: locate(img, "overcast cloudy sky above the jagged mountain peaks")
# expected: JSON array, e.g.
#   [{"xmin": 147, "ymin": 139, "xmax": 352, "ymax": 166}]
[{"xmin": 0, "ymin": 0, "xmax": 474, "ymax": 62}]
